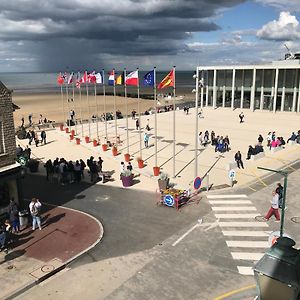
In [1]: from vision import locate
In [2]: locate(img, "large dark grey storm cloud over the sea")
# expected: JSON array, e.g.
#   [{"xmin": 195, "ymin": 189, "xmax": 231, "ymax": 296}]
[{"xmin": 0, "ymin": 0, "xmax": 245, "ymax": 70}]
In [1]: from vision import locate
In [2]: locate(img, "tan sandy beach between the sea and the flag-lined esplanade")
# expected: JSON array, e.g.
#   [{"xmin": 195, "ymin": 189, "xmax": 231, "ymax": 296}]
[{"xmin": 12, "ymin": 93, "xmax": 154, "ymax": 126}]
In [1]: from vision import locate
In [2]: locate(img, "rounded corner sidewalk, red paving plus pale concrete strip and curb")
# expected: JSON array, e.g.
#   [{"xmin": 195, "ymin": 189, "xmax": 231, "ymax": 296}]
[{"xmin": 0, "ymin": 204, "xmax": 103, "ymax": 299}]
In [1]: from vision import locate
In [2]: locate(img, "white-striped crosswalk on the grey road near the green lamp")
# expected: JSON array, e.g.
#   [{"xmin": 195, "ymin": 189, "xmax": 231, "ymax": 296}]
[{"xmin": 207, "ymin": 195, "xmax": 271, "ymax": 275}]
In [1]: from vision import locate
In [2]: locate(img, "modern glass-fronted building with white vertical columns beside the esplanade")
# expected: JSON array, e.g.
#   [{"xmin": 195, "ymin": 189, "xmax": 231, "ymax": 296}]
[{"xmin": 196, "ymin": 59, "xmax": 300, "ymax": 113}]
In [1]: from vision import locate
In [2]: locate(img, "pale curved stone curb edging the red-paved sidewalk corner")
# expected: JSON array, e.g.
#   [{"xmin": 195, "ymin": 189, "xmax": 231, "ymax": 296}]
[{"xmin": 0, "ymin": 199, "xmax": 104, "ymax": 300}]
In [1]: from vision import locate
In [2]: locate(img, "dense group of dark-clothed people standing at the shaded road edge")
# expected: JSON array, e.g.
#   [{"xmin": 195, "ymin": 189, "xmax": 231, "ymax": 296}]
[{"xmin": 44, "ymin": 156, "xmax": 103, "ymax": 185}]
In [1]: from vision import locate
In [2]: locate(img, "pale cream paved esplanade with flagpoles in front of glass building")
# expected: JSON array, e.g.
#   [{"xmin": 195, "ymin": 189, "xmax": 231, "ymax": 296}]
[{"xmin": 20, "ymin": 108, "xmax": 300, "ymax": 191}]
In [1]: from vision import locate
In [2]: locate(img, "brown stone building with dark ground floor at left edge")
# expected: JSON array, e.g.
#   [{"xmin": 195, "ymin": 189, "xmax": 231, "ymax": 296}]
[{"xmin": 0, "ymin": 82, "xmax": 22, "ymax": 215}]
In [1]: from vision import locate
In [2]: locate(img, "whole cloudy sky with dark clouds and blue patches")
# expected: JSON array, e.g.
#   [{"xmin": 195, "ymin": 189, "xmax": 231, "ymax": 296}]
[{"xmin": 0, "ymin": 0, "xmax": 300, "ymax": 72}]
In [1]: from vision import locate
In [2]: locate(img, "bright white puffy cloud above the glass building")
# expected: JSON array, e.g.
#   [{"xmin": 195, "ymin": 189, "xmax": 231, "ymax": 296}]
[{"xmin": 256, "ymin": 12, "xmax": 300, "ymax": 41}]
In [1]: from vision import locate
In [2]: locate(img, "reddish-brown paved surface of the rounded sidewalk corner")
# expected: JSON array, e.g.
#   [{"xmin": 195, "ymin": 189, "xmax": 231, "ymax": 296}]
[{"xmin": 13, "ymin": 205, "xmax": 102, "ymax": 262}]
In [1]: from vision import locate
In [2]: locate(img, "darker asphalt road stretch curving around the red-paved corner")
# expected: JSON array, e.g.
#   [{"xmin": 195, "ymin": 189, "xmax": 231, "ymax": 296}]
[{"xmin": 23, "ymin": 175, "xmax": 209, "ymax": 267}]
